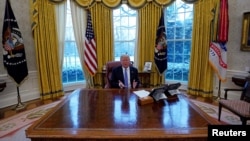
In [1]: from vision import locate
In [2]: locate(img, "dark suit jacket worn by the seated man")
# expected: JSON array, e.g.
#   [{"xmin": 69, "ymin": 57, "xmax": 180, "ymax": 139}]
[{"xmin": 111, "ymin": 66, "xmax": 140, "ymax": 88}]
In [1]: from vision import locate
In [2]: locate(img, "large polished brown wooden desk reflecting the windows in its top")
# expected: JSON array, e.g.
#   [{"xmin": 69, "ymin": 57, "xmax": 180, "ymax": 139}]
[{"xmin": 26, "ymin": 89, "xmax": 219, "ymax": 141}]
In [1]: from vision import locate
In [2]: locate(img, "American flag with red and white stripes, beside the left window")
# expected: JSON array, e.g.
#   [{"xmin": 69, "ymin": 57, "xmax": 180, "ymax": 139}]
[{"xmin": 84, "ymin": 11, "xmax": 97, "ymax": 76}]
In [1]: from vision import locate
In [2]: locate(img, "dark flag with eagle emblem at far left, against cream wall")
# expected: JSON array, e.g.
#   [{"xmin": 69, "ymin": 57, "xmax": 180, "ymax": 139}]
[{"xmin": 2, "ymin": 0, "xmax": 28, "ymax": 85}]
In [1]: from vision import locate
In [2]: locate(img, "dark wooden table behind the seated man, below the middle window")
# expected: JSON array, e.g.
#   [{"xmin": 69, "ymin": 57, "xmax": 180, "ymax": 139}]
[{"xmin": 102, "ymin": 71, "xmax": 153, "ymax": 88}]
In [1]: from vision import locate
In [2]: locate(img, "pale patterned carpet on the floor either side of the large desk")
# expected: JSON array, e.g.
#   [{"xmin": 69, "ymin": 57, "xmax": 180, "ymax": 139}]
[{"xmin": 0, "ymin": 100, "xmax": 246, "ymax": 141}]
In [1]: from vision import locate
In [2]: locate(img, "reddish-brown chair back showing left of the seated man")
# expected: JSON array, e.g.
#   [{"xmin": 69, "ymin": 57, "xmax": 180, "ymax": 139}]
[{"xmin": 104, "ymin": 61, "xmax": 121, "ymax": 88}]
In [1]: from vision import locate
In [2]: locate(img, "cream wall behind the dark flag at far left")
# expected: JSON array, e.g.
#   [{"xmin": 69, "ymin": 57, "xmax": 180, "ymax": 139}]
[{"xmin": 0, "ymin": 0, "xmax": 39, "ymax": 108}]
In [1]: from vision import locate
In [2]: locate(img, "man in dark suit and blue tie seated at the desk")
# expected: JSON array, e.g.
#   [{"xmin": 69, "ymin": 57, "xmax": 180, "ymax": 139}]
[{"xmin": 111, "ymin": 55, "xmax": 140, "ymax": 88}]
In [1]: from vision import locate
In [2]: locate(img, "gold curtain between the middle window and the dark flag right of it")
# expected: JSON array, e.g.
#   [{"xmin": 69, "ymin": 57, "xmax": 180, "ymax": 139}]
[{"xmin": 137, "ymin": 3, "xmax": 165, "ymax": 87}]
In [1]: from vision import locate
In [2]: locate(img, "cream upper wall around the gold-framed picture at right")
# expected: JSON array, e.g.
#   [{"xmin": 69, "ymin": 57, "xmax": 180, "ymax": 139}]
[{"xmin": 227, "ymin": 0, "xmax": 250, "ymax": 71}]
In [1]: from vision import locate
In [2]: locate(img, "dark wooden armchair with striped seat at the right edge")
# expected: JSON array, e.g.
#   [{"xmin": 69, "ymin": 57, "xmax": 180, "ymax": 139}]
[{"xmin": 218, "ymin": 81, "xmax": 250, "ymax": 125}]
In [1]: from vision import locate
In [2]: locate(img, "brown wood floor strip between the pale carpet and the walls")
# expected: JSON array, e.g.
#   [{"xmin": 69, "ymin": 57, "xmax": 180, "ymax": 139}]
[{"xmin": 0, "ymin": 90, "xmax": 218, "ymax": 120}]
